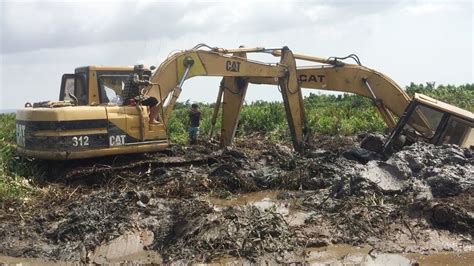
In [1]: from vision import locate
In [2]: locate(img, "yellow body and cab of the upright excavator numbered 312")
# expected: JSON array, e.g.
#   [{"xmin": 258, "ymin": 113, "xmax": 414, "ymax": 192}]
[{"xmin": 16, "ymin": 66, "xmax": 169, "ymax": 160}]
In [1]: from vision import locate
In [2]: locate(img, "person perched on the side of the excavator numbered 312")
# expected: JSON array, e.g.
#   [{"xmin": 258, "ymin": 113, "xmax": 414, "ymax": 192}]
[{"xmin": 122, "ymin": 65, "xmax": 159, "ymax": 124}]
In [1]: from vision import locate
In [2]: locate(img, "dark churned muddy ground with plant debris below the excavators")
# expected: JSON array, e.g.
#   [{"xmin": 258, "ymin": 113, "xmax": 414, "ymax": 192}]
[{"xmin": 0, "ymin": 135, "xmax": 474, "ymax": 263}]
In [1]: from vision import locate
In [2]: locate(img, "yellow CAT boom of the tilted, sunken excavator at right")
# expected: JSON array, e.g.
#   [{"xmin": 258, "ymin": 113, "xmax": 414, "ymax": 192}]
[{"xmin": 249, "ymin": 51, "xmax": 433, "ymax": 134}]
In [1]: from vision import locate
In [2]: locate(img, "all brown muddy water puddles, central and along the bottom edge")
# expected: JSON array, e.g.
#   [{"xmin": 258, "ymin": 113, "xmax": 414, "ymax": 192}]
[{"xmin": 0, "ymin": 190, "xmax": 474, "ymax": 265}]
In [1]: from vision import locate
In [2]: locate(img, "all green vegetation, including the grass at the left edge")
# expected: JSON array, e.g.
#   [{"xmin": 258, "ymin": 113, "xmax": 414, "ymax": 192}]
[{"xmin": 0, "ymin": 83, "xmax": 474, "ymax": 204}]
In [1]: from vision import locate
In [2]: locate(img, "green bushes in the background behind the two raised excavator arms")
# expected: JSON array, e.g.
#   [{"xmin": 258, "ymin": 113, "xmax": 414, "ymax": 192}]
[{"xmin": 168, "ymin": 83, "xmax": 474, "ymax": 144}]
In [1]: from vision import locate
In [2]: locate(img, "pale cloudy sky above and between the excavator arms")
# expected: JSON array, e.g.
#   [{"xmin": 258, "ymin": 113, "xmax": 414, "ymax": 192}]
[{"xmin": 0, "ymin": 0, "xmax": 474, "ymax": 109}]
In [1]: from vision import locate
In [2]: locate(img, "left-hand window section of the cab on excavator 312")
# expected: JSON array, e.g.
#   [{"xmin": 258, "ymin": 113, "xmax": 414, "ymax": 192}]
[{"xmin": 59, "ymin": 74, "xmax": 88, "ymax": 105}]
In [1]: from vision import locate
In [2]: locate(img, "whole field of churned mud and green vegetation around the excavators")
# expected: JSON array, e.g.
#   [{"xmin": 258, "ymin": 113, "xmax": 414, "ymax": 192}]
[{"xmin": 0, "ymin": 83, "xmax": 474, "ymax": 263}]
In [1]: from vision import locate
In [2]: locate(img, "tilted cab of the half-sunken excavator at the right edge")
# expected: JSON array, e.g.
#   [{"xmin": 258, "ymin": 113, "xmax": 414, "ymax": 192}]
[{"xmin": 384, "ymin": 93, "xmax": 474, "ymax": 154}]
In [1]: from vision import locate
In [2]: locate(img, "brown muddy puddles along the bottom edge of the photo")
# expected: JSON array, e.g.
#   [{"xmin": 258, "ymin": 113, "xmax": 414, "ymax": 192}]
[{"xmin": 0, "ymin": 244, "xmax": 474, "ymax": 266}]
